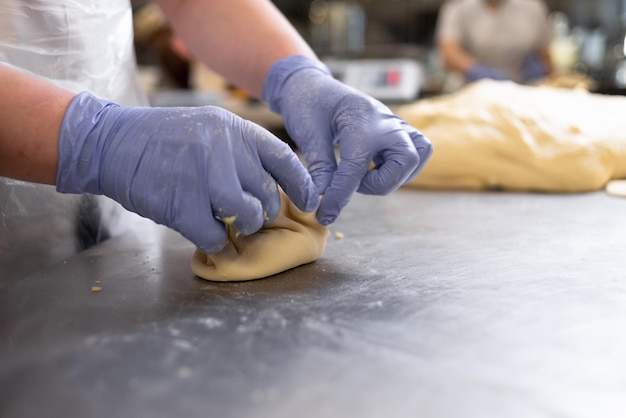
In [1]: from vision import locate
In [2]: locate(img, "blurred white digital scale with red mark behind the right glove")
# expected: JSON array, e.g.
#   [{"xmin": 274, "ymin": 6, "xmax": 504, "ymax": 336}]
[{"xmin": 324, "ymin": 58, "xmax": 424, "ymax": 102}]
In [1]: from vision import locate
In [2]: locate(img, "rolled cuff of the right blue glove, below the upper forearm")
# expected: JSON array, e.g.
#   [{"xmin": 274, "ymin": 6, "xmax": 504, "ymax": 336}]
[{"xmin": 262, "ymin": 55, "xmax": 332, "ymax": 114}]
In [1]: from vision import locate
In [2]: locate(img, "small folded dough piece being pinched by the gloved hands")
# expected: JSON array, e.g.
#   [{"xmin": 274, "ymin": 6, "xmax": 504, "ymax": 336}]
[{"xmin": 191, "ymin": 190, "xmax": 329, "ymax": 282}]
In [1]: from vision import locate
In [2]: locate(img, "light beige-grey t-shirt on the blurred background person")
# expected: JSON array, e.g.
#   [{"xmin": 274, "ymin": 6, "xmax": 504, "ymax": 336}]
[{"xmin": 437, "ymin": 0, "xmax": 552, "ymax": 81}]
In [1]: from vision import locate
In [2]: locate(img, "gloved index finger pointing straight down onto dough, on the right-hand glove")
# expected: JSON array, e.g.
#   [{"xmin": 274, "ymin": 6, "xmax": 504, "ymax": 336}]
[{"xmin": 317, "ymin": 155, "xmax": 369, "ymax": 225}]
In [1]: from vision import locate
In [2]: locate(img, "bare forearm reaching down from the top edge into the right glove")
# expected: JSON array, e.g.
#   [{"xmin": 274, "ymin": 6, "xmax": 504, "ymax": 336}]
[{"xmin": 158, "ymin": 0, "xmax": 315, "ymax": 97}]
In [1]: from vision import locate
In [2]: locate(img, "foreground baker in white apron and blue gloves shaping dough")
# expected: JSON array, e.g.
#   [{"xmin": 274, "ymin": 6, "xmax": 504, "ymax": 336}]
[{"xmin": 0, "ymin": 0, "xmax": 432, "ymax": 272}]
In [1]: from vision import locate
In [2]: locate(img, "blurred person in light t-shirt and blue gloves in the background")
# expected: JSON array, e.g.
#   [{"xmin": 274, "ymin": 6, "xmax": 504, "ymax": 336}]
[{"xmin": 436, "ymin": 0, "xmax": 552, "ymax": 83}]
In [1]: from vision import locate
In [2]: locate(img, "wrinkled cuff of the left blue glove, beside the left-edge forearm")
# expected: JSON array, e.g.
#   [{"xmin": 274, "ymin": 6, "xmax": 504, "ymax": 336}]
[{"xmin": 56, "ymin": 92, "xmax": 119, "ymax": 194}]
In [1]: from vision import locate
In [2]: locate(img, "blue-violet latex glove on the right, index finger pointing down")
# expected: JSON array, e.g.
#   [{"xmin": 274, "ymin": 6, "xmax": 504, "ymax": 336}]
[{"xmin": 263, "ymin": 56, "xmax": 433, "ymax": 225}]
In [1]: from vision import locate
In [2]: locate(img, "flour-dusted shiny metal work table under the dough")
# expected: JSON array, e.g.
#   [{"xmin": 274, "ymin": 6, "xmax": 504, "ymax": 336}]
[{"xmin": 0, "ymin": 190, "xmax": 626, "ymax": 418}]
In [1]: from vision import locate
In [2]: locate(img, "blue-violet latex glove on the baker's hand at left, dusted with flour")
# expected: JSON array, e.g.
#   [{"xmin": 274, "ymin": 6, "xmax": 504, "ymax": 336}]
[{"xmin": 57, "ymin": 93, "xmax": 319, "ymax": 254}]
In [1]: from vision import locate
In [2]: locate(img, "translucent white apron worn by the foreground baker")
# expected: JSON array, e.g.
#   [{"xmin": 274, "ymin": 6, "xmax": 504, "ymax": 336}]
[{"xmin": 0, "ymin": 0, "xmax": 148, "ymax": 280}]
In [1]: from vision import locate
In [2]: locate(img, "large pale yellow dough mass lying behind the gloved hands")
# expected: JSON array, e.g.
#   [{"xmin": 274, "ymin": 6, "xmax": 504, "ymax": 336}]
[{"xmin": 396, "ymin": 80, "xmax": 626, "ymax": 193}]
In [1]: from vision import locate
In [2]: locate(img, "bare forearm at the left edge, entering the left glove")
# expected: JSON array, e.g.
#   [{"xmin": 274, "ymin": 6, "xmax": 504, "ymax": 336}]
[{"xmin": 0, "ymin": 65, "xmax": 74, "ymax": 184}]
